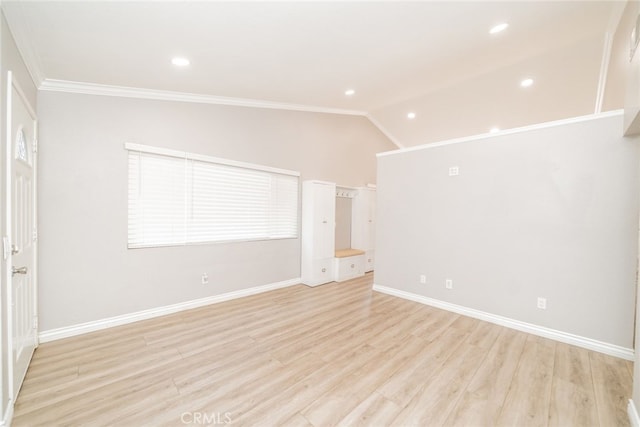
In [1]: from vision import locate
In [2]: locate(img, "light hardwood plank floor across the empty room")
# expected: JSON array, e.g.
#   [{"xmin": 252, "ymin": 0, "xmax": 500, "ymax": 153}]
[{"xmin": 13, "ymin": 274, "xmax": 632, "ymax": 427}]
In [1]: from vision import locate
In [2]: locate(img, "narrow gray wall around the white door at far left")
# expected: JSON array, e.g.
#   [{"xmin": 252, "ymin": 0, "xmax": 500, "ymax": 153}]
[{"xmin": 0, "ymin": 10, "xmax": 36, "ymax": 420}]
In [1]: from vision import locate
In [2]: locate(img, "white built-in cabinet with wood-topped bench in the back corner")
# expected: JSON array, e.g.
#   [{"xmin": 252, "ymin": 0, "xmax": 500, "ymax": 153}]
[{"xmin": 301, "ymin": 180, "xmax": 375, "ymax": 286}]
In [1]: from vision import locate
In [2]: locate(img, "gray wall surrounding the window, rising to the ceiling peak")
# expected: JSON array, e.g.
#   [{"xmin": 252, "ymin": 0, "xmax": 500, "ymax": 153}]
[{"xmin": 39, "ymin": 92, "xmax": 395, "ymax": 331}]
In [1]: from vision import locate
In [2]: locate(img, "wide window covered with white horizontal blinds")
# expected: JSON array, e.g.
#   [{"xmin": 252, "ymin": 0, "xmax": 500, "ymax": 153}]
[{"xmin": 125, "ymin": 144, "xmax": 299, "ymax": 248}]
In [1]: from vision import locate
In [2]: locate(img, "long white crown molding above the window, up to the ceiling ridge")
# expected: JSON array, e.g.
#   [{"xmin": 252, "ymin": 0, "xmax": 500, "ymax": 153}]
[{"xmin": 38, "ymin": 79, "xmax": 367, "ymax": 116}]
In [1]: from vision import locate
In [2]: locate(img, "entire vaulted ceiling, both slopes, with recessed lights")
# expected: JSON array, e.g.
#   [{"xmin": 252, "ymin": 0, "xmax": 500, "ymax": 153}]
[{"xmin": 2, "ymin": 0, "xmax": 625, "ymax": 145}]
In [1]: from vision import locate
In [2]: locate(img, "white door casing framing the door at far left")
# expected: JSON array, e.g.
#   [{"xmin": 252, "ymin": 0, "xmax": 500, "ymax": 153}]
[{"xmin": 0, "ymin": 71, "xmax": 38, "ymax": 412}]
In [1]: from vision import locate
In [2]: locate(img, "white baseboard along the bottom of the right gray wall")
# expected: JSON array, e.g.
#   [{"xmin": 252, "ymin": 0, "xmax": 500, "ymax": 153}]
[{"xmin": 373, "ymin": 284, "xmax": 640, "ymax": 362}]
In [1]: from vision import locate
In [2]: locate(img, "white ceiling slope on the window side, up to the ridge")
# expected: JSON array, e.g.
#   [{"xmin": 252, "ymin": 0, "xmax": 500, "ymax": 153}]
[{"xmin": 2, "ymin": 0, "xmax": 624, "ymax": 116}]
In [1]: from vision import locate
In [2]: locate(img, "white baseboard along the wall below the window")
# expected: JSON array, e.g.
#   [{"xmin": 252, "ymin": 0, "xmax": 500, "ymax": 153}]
[{"xmin": 39, "ymin": 277, "xmax": 300, "ymax": 343}]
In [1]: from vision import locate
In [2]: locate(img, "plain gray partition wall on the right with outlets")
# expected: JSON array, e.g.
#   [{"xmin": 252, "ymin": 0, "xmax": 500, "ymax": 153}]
[{"xmin": 375, "ymin": 115, "xmax": 639, "ymax": 348}]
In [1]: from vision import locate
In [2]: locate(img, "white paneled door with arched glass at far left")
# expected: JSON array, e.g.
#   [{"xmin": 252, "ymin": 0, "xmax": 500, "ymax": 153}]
[{"xmin": 7, "ymin": 74, "xmax": 37, "ymax": 399}]
